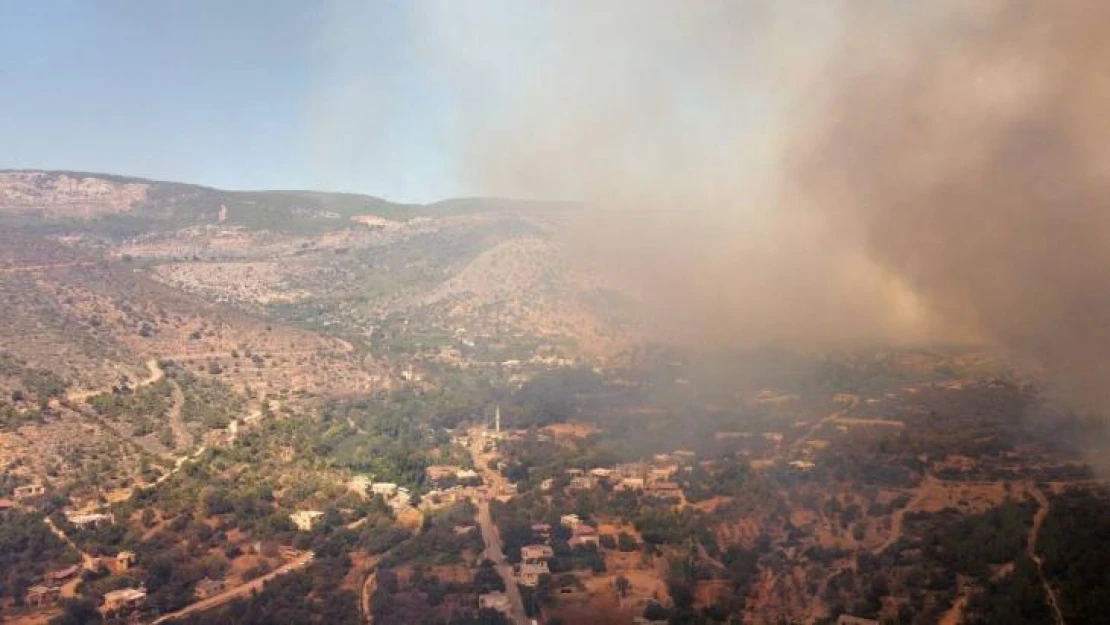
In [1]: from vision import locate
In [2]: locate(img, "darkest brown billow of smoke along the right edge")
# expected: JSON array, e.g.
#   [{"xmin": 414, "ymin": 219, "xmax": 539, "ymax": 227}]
[{"xmin": 794, "ymin": 0, "xmax": 1110, "ymax": 409}]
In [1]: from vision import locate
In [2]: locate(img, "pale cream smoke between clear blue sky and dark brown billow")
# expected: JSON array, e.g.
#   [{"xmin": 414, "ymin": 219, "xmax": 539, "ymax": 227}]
[{"xmin": 392, "ymin": 1, "xmax": 936, "ymax": 345}]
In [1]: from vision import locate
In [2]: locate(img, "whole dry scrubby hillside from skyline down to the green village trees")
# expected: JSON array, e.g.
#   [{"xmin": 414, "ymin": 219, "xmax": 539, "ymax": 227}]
[{"xmin": 0, "ymin": 171, "xmax": 639, "ymax": 503}]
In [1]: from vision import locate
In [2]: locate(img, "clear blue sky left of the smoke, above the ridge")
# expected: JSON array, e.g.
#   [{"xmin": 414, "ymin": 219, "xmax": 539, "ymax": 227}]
[{"xmin": 0, "ymin": 0, "xmax": 464, "ymax": 201}]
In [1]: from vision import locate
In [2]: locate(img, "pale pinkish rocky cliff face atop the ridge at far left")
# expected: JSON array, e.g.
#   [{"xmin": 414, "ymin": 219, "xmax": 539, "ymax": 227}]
[{"xmin": 0, "ymin": 171, "xmax": 150, "ymax": 219}]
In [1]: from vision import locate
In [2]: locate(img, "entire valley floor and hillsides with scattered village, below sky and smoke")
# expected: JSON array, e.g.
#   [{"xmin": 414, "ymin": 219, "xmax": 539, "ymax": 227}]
[{"xmin": 0, "ymin": 172, "xmax": 1110, "ymax": 625}]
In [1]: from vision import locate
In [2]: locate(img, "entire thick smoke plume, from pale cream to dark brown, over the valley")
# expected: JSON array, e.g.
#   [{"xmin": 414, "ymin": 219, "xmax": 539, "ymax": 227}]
[{"xmin": 310, "ymin": 0, "xmax": 1110, "ymax": 406}]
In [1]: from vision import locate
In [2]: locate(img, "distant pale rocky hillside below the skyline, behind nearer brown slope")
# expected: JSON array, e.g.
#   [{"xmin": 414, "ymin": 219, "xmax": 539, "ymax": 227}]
[{"xmin": 0, "ymin": 171, "xmax": 643, "ymax": 360}]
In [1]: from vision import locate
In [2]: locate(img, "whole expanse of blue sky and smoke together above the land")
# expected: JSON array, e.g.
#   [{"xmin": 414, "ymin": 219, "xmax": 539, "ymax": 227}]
[{"xmin": 0, "ymin": 0, "xmax": 1110, "ymax": 415}]
